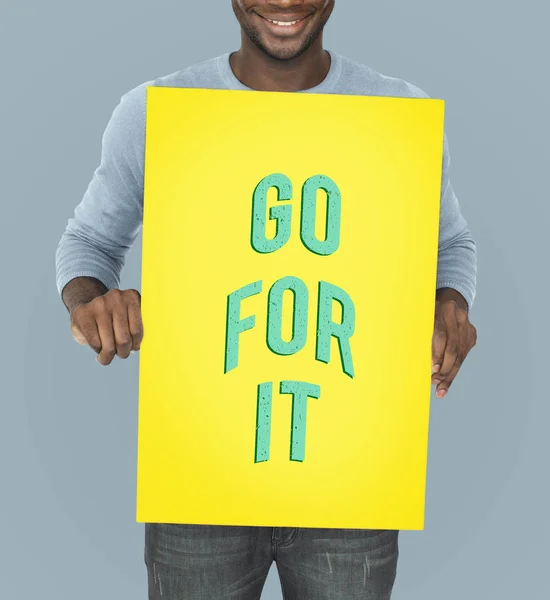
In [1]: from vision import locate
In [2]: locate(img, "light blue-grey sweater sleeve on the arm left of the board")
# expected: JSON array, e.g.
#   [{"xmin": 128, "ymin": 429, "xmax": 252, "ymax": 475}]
[{"xmin": 55, "ymin": 84, "xmax": 146, "ymax": 296}]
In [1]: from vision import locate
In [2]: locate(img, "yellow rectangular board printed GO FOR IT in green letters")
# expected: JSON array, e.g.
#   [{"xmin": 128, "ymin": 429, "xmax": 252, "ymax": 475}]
[{"xmin": 137, "ymin": 87, "xmax": 444, "ymax": 529}]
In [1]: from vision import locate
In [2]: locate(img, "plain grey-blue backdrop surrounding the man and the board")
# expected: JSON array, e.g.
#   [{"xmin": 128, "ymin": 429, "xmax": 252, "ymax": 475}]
[{"xmin": 0, "ymin": 0, "xmax": 550, "ymax": 600}]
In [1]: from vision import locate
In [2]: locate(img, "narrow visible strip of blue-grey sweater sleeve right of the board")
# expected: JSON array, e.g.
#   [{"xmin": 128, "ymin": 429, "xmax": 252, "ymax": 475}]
[{"xmin": 436, "ymin": 135, "xmax": 477, "ymax": 308}]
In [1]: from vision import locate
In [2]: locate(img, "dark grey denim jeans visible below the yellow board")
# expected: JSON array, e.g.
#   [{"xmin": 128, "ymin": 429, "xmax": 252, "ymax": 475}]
[{"xmin": 144, "ymin": 523, "xmax": 399, "ymax": 600}]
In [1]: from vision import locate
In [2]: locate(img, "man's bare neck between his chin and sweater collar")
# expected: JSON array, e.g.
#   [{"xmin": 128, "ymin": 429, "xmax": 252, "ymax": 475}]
[{"xmin": 229, "ymin": 36, "xmax": 330, "ymax": 92}]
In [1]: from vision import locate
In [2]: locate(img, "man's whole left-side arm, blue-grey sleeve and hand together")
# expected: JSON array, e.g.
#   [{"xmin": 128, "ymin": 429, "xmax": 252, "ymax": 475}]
[{"xmin": 56, "ymin": 84, "xmax": 149, "ymax": 364}]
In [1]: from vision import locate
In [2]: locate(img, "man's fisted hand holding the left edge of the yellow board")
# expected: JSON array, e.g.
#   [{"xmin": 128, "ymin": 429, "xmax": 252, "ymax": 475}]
[{"xmin": 70, "ymin": 289, "xmax": 143, "ymax": 366}]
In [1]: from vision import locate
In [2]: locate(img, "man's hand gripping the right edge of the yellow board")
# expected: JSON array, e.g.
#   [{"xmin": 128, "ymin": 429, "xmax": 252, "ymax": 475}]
[{"xmin": 432, "ymin": 290, "xmax": 477, "ymax": 398}]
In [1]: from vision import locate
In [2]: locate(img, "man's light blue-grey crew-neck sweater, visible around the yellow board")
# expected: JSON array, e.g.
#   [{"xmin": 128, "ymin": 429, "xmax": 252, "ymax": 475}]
[{"xmin": 56, "ymin": 51, "xmax": 477, "ymax": 308}]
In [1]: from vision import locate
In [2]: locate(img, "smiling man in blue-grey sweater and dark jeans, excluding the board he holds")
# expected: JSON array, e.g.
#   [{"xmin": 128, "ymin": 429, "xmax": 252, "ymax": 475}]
[{"xmin": 56, "ymin": 0, "xmax": 477, "ymax": 600}]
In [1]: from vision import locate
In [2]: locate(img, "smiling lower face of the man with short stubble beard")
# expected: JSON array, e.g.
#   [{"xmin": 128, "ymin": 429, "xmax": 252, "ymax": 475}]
[{"xmin": 232, "ymin": 0, "xmax": 335, "ymax": 60}]
